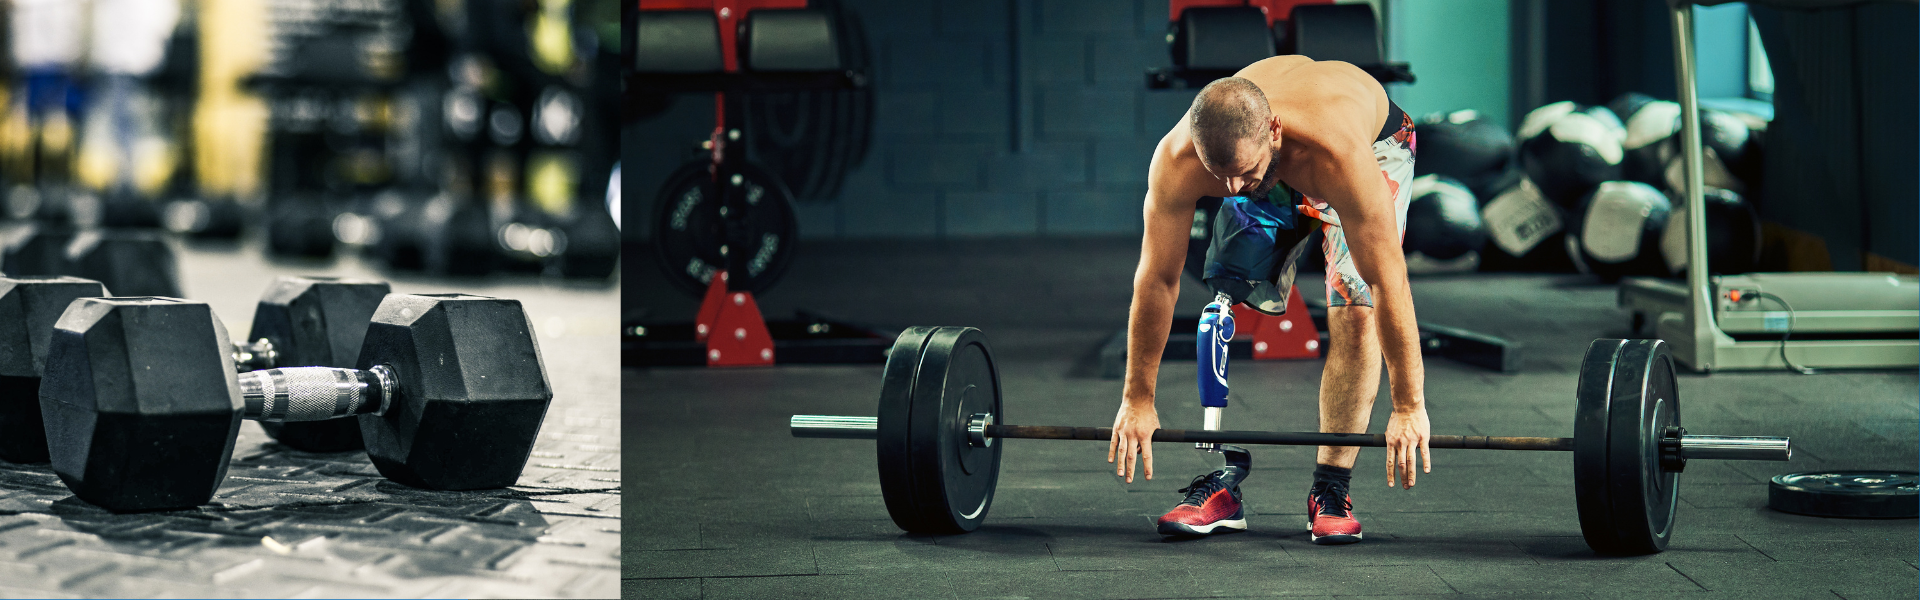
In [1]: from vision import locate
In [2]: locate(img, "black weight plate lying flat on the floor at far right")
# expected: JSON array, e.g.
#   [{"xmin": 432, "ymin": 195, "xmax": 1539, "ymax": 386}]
[{"xmin": 1766, "ymin": 471, "xmax": 1920, "ymax": 519}]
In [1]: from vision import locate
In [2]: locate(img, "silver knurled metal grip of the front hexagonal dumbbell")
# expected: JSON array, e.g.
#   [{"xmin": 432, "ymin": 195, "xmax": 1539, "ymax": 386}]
[{"xmin": 240, "ymin": 365, "xmax": 394, "ymax": 423}]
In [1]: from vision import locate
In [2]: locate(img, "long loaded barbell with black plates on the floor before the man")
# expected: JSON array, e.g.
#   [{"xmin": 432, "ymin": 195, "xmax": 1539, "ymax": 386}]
[{"xmin": 789, "ymin": 327, "xmax": 1793, "ymax": 554}]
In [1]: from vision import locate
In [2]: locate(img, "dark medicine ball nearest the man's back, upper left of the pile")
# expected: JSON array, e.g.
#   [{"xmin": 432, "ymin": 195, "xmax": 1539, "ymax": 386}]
[{"xmin": 1413, "ymin": 110, "xmax": 1513, "ymax": 198}]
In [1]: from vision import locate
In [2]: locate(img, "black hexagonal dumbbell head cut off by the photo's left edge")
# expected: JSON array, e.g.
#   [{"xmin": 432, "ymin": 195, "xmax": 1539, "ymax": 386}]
[{"xmin": 0, "ymin": 275, "xmax": 108, "ymax": 463}]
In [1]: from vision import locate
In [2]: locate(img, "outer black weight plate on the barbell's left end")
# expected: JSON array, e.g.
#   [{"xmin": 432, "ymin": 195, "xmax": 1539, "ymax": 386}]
[{"xmin": 874, "ymin": 327, "xmax": 937, "ymax": 531}]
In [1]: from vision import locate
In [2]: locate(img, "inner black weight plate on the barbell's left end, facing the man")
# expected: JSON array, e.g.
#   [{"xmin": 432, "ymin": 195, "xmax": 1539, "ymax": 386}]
[{"xmin": 910, "ymin": 327, "xmax": 1002, "ymax": 533}]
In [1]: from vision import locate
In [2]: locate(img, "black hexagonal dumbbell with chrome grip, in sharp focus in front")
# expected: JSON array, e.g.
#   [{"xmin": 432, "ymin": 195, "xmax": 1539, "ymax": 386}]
[{"xmin": 40, "ymin": 294, "xmax": 553, "ymax": 512}]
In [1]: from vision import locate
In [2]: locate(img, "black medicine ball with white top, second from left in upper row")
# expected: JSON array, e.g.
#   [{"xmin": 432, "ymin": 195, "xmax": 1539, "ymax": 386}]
[{"xmin": 1521, "ymin": 102, "xmax": 1624, "ymax": 210}]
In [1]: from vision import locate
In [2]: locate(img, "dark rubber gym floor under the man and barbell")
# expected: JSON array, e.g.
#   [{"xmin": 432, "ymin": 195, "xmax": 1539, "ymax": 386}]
[{"xmin": 622, "ymin": 240, "xmax": 1920, "ymax": 598}]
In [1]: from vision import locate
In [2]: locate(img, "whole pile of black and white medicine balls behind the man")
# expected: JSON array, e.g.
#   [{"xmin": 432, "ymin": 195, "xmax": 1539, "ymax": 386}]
[{"xmin": 1402, "ymin": 92, "xmax": 1766, "ymax": 281}]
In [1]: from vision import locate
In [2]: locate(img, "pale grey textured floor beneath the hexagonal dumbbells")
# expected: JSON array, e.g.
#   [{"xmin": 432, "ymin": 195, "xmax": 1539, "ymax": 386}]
[{"xmin": 0, "ymin": 246, "xmax": 620, "ymax": 598}]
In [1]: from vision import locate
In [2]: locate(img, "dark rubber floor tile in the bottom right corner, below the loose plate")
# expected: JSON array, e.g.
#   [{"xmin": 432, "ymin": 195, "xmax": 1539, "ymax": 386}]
[{"xmin": 1672, "ymin": 558, "xmax": 1914, "ymax": 598}]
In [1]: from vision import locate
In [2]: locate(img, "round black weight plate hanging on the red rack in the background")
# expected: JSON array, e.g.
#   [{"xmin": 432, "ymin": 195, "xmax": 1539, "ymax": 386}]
[{"xmin": 653, "ymin": 158, "xmax": 799, "ymax": 298}]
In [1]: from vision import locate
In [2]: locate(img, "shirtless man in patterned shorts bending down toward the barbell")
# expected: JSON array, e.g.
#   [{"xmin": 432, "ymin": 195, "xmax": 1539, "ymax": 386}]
[{"xmin": 1106, "ymin": 56, "xmax": 1432, "ymax": 544}]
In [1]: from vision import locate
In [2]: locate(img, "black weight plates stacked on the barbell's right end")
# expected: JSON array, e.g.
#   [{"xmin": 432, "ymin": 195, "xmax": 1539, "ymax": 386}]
[{"xmin": 1574, "ymin": 340, "xmax": 1680, "ymax": 554}]
